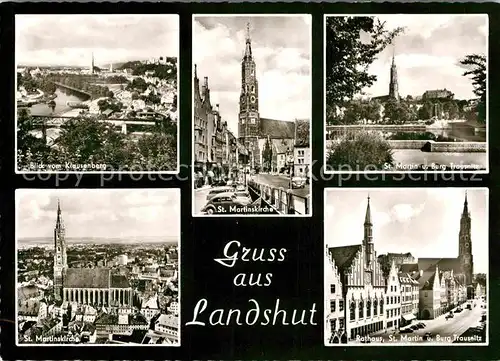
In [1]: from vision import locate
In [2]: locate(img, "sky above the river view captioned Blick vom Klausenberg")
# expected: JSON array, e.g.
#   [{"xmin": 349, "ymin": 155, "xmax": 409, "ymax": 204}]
[{"xmin": 16, "ymin": 14, "xmax": 179, "ymax": 66}]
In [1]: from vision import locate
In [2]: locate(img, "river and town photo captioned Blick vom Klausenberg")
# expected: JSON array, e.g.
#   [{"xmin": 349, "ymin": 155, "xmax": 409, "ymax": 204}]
[{"xmin": 15, "ymin": 14, "xmax": 179, "ymax": 173}]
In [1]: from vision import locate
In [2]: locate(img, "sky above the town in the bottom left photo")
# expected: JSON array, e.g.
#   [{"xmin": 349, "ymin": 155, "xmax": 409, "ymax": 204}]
[{"xmin": 16, "ymin": 189, "xmax": 180, "ymax": 238}]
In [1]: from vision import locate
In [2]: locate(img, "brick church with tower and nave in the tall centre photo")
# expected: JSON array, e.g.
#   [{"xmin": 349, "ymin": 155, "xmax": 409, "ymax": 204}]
[{"xmin": 238, "ymin": 24, "xmax": 303, "ymax": 167}]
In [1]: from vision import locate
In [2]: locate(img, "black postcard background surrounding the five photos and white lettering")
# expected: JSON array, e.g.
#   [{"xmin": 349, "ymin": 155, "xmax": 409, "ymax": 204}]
[{"xmin": 0, "ymin": 3, "xmax": 500, "ymax": 360}]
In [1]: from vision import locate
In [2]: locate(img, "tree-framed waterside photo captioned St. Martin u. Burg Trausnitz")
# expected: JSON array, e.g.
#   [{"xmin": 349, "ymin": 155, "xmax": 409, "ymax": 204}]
[{"xmin": 325, "ymin": 14, "xmax": 488, "ymax": 173}]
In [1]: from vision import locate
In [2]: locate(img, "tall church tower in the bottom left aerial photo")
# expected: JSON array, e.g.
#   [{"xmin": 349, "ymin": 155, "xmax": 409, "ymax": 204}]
[{"xmin": 54, "ymin": 199, "xmax": 68, "ymax": 300}]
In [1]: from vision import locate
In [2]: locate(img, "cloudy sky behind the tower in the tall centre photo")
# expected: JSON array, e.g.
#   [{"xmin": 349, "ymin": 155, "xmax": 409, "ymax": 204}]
[{"xmin": 193, "ymin": 15, "xmax": 312, "ymax": 135}]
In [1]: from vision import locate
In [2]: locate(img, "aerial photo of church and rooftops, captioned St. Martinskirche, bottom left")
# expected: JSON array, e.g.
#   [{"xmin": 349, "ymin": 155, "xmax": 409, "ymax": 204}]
[{"xmin": 16, "ymin": 189, "xmax": 180, "ymax": 346}]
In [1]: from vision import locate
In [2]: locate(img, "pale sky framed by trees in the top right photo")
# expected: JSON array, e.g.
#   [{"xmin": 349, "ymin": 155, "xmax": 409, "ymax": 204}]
[{"xmin": 352, "ymin": 14, "xmax": 488, "ymax": 99}]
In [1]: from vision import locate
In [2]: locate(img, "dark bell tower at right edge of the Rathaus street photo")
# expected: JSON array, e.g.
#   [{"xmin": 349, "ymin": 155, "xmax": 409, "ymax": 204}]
[{"xmin": 458, "ymin": 192, "xmax": 473, "ymax": 285}]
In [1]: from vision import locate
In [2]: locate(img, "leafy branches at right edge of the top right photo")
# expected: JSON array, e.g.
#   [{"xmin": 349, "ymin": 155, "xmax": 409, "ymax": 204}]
[{"xmin": 460, "ymin": 54, "xmax": 486, "ymax": 122}]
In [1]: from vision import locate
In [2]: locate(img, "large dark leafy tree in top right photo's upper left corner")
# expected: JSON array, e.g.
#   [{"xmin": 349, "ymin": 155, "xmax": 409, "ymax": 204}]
[{"xmin": 325, "ymin": 16, "xmax": 403, "ymax": 106}]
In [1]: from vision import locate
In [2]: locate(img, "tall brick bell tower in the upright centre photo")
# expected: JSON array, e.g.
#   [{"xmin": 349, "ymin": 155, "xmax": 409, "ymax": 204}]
[{"xmin": 238, "ymin": 24, "xmax": 260, "ymax": 159}]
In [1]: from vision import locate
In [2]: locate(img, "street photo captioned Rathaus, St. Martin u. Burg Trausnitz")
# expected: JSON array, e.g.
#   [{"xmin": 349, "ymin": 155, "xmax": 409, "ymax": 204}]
[{"xmin": 324, "ymin": 188, "xmax": 489, "ymax": 346}]
